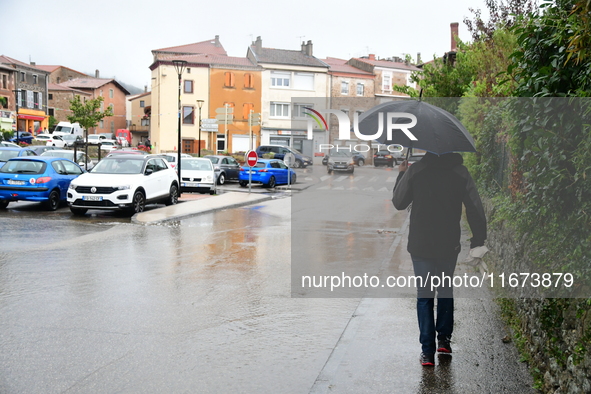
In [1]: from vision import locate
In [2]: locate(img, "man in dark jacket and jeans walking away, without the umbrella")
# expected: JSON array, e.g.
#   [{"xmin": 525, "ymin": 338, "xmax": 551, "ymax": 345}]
[{"xmin": 392, "ymin": 152, "xmax": 486, "ymax": 366}]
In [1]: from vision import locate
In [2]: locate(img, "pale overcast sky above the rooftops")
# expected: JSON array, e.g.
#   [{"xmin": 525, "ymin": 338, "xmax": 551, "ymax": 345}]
[{"xmin": 0, "ymin": 0, "xmax": 486, "ymax": 89}]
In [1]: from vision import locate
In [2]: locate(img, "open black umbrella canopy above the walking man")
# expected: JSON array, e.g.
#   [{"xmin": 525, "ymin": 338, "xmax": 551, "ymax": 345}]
[{"xmin": 358, "ymin": 100, "xmax": 476, "ymax": 155}]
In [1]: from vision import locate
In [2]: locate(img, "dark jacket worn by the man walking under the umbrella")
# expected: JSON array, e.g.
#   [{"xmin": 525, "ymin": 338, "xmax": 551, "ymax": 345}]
[{"xmin": 392, "ymin": 153, "xmax": 486, "ymax": 258}]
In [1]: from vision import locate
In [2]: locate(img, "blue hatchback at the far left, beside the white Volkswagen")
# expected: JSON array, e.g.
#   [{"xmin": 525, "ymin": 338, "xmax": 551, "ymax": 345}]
[{"xmin": 0, "ymin": 156, "xmax": 84, "ymax": 211}]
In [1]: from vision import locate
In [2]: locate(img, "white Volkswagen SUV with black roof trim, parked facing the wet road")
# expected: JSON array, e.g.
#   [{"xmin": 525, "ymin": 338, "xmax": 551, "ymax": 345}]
[{"xmin": 68, "ymin": 155, "xmax": 179, "ymax": 215}]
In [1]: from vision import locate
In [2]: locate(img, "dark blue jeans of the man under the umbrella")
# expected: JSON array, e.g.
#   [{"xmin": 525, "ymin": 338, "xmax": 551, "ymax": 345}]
[{"xmin": 411, "ymin": 255, "xmax": 458, "ymax": 354}]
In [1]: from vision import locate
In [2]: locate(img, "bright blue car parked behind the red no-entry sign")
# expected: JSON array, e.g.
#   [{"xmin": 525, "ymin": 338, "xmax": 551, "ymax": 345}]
[{"xmin": 238, "ymin": 159, "xmax": 296, "ymax": 188}]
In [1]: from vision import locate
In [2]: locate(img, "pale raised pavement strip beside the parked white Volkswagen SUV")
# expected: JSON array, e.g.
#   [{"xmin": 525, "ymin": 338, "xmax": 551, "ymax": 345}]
[{"xmin": 131, "ymin": 192, "xmax": 273, "ymax": 224}]
